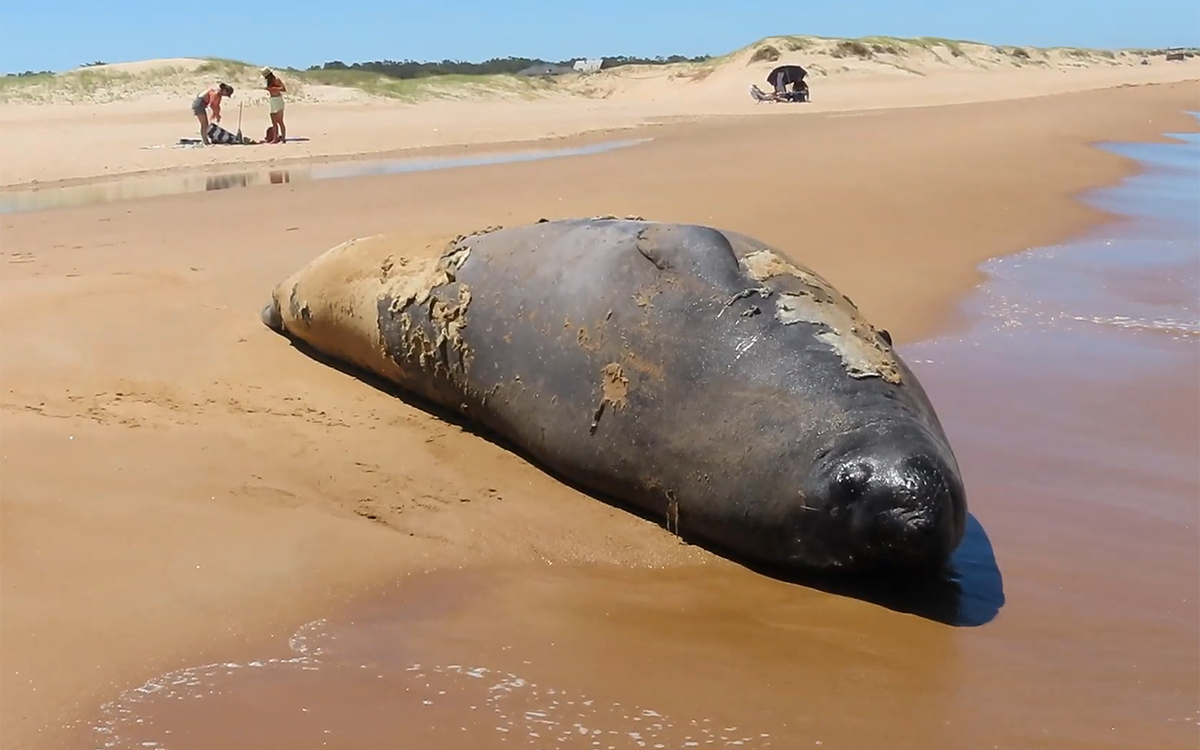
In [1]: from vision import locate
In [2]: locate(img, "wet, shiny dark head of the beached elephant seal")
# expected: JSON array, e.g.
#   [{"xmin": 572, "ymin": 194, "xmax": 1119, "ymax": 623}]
[{"xmin": 788, "ymin": 420, "xmax": 967, "ymax": 571}]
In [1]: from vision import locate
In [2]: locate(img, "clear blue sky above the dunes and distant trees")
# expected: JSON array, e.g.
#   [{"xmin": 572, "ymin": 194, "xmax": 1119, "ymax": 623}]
[{"xmin": 0, "ymin": 0, "xmax": 1200, "ymax": 73}]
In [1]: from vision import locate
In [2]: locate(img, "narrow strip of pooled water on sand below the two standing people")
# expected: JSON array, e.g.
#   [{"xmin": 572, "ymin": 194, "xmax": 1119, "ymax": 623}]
[{"xmin": 0, "ymin": 138, "xmax": 650, "ymax": 214}]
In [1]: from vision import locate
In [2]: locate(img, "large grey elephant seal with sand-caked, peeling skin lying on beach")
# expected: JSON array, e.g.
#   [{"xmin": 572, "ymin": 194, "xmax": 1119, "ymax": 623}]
[{"xmin": 262, "ymin": 217, "xmax": 967, "ymax": 571}]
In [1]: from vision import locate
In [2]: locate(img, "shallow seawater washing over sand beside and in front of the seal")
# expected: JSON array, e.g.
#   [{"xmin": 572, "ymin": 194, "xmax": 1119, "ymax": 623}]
[{"xmin": 77, "ymin": 121, "xmax": 1200, "ymax": 750}]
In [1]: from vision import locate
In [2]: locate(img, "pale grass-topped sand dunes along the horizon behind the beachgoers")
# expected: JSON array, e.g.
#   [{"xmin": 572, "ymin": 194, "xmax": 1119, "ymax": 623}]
[{"xmin": 0, "ymin": 36, "xmax": 1195, "ymax": 103}]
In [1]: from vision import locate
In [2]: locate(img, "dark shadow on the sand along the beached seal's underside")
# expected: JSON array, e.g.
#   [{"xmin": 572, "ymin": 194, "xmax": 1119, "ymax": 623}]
[{"xmin": 284, "ymin": 335, "xmax": 1004, "ymax": 626}]
